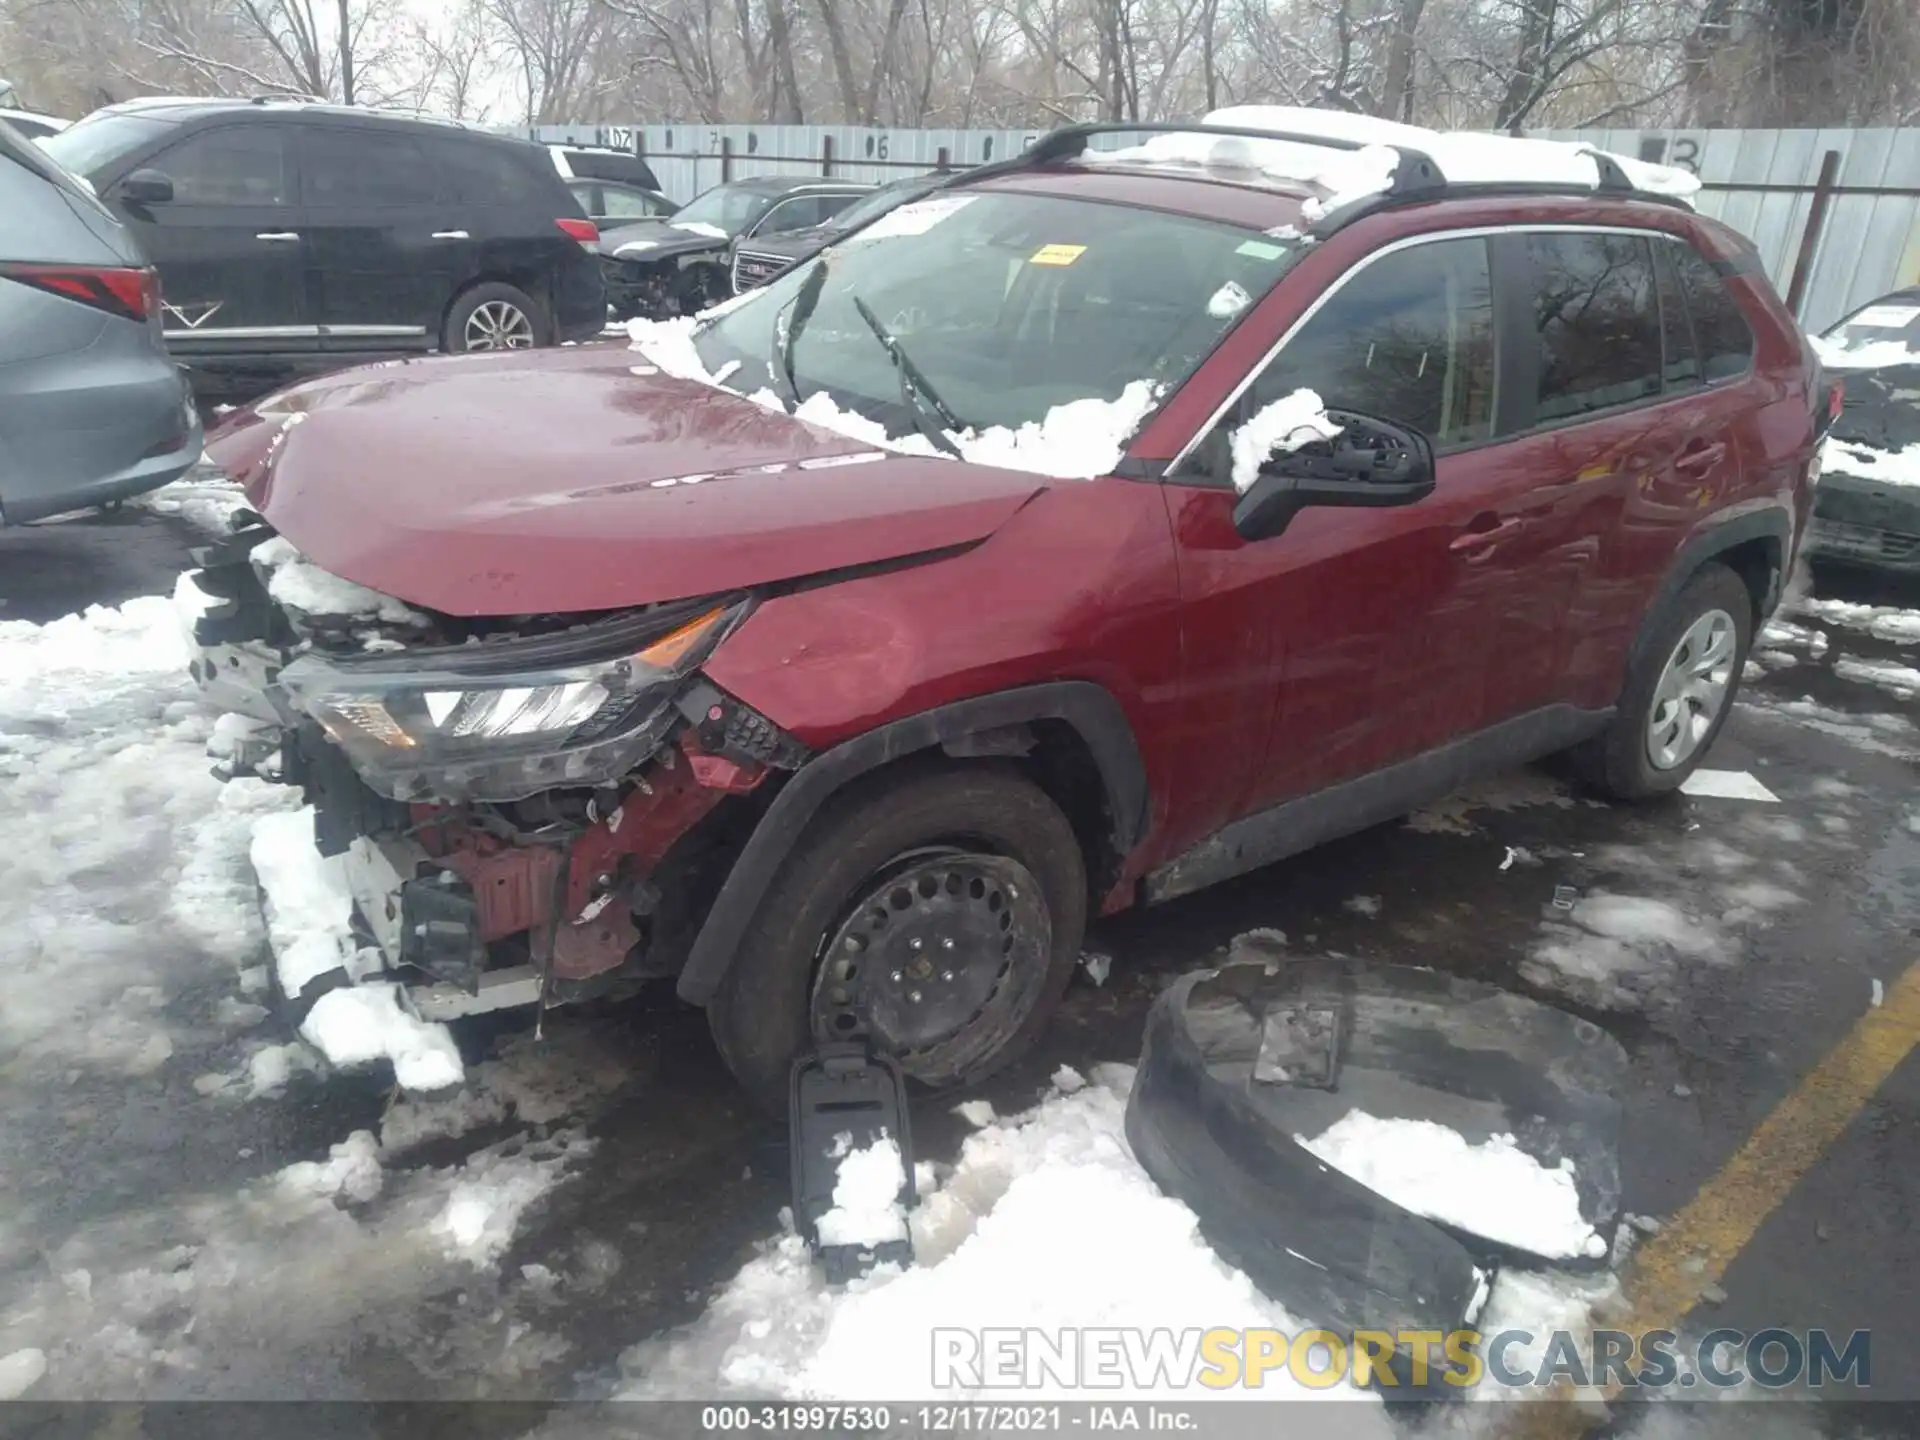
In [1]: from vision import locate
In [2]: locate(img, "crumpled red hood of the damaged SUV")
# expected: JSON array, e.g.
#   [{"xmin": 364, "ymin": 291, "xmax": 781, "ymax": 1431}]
[{"xmin": 207, "ymin": 346, "xmax": 1046, "ymax": 616}]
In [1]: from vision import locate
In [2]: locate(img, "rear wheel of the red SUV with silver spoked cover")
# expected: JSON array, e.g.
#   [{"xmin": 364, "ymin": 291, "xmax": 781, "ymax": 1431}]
[{"xmin": 1571, "ymin": 564, "xmax": 1753, "ymax": 801}]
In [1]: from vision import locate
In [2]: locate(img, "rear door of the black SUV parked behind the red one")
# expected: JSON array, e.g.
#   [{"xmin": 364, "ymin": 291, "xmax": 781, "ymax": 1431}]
[{"xmin": 298, "ymin": 123, "xmax": 474, "ymax": 351}]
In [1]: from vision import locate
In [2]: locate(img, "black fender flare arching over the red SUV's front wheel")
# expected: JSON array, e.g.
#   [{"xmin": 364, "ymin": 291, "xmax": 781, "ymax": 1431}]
[{"xmin": 676, "ymin": 680, "xmax": 1150, "ymax": 1004}]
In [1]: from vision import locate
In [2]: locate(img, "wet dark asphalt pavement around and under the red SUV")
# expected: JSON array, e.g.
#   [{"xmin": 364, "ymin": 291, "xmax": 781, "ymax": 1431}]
[{"xmin": 0, "ymin": 509, "xmax": 1920, "ymax": 1434}]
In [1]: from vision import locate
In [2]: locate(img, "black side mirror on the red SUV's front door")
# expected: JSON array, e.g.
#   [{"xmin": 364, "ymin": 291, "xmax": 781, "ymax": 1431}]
[{"xmin": 1233, "ymin": 411, "xmax": 1434, "ymax": 540}]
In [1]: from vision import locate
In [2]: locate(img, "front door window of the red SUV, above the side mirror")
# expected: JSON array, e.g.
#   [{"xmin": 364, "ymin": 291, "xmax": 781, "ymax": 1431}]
[{"xmin": 1246, "ymin": 238, "xmax": 1494, "ymax": 447}]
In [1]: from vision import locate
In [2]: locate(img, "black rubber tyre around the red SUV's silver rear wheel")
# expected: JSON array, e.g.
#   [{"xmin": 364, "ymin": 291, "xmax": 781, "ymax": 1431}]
[{"xmin": 1567, "ymin": 563, "xmax": 1753, "ymax": 801}]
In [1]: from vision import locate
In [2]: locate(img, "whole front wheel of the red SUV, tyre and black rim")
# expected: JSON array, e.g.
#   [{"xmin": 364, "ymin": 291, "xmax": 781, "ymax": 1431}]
[{"xmin": 707, "ymin": 764, "xmax": 1087, "ymax": 1112}]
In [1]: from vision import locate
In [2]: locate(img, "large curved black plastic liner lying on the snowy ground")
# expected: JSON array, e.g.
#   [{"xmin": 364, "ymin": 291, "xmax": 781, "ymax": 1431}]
[{"xmin": 1127, "ymin": 958, "xmax": 1628, "ymax": 1374}]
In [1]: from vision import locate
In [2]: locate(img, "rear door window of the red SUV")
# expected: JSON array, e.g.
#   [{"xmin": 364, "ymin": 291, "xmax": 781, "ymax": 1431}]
[{"xmin": 1526, "ymin": 232, "xmax": 1663, "ymax": 422}]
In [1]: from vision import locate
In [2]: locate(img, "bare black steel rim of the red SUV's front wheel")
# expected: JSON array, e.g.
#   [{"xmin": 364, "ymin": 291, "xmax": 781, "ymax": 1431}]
[{"xmin": 808, "ymin": 847, "xmax": 1052, "ymax": 1083}]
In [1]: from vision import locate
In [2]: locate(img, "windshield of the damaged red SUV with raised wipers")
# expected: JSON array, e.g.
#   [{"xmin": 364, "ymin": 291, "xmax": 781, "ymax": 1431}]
[{"xmin": 695, "ymin": 192, "xmax": 1292, "ymax": 434}]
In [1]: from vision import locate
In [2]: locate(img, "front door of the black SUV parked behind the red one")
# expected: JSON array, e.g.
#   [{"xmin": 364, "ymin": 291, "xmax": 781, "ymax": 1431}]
[{"xmin": 108, "ymin": 117, "xmax": 319, "ymax": 361}]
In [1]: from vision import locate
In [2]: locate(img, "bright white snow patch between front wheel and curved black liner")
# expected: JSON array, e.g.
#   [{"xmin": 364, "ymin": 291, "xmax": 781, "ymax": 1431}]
[{"xmin": 620, "ymin": 1066, "xmax": 1390, "ymax": 1402}]
